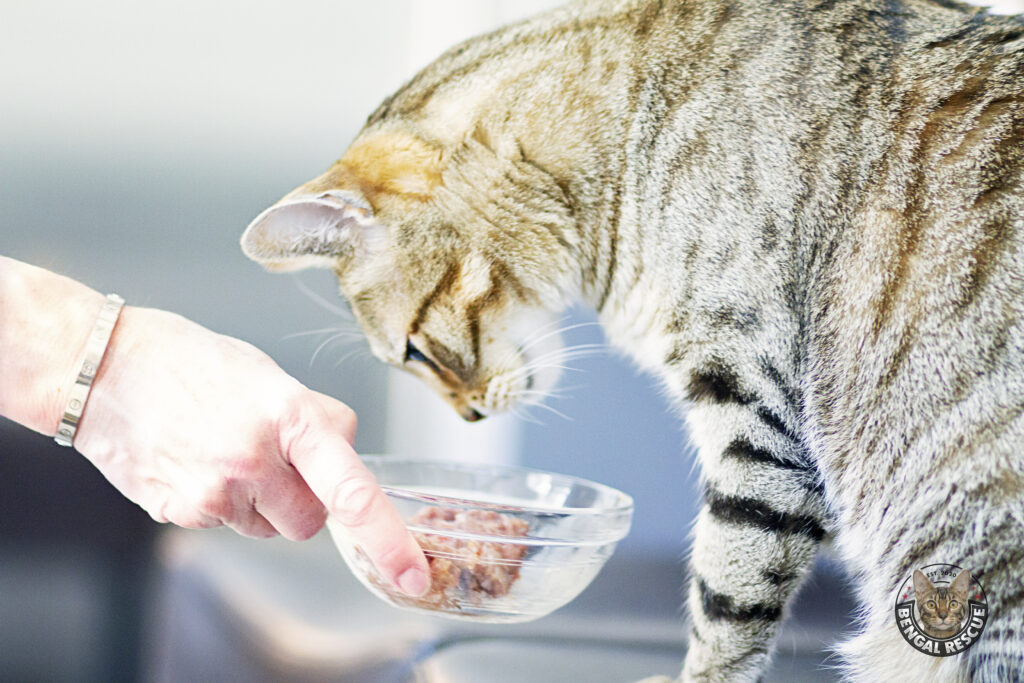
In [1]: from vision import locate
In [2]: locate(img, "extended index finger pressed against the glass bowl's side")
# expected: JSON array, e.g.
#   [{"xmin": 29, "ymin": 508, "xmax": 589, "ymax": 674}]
[{"xmin": 288, "ymin": 417, "xmax": 429, "ymax": 596}]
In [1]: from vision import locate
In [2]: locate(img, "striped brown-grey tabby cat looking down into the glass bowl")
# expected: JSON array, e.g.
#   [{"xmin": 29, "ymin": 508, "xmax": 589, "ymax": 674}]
[{"xmin": 242, "ymin": 0, "xmax": 1024, "ymax": 683}]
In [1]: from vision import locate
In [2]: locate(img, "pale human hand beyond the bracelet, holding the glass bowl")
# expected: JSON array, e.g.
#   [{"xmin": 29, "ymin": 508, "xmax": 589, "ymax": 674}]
[{"xmin": 75, "ymin": 303, "xmax": 429, "ymax": 595}]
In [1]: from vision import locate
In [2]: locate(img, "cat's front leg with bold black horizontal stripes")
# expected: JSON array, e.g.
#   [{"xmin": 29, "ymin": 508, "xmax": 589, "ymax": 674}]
[{"xmin": 682, "ymin": 396, "xmax": 826, "ymax": 682}]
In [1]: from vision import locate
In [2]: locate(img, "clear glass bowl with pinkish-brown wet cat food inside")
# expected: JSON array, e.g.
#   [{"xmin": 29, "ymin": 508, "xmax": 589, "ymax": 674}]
[{"xmin": 328, "ymin": 456, "xmax": 633, "ymax": 623}]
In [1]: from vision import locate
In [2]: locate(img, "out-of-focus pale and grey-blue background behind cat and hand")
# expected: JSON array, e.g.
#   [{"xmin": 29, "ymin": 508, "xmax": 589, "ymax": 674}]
[{"xmin": 0, "ymin": 0, "xmax": 1020, "ymax": 682}]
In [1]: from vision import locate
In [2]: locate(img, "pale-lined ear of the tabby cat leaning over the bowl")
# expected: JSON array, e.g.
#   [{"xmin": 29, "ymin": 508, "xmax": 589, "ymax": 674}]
[{"xmin": 242, "ymin": 189, "xmax": 385, "ymax": 271}]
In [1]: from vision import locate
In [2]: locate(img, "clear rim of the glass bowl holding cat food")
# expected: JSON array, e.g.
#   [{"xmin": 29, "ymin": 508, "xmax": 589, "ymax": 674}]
[{"xmin": 361, "ymin": 454, "xmax": 634, "ymax": 516}]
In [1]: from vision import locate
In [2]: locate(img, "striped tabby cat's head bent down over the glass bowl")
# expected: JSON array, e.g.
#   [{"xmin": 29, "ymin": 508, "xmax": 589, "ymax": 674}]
[{"xmin": 242, "ymin": 127, "xmax": 579, "ymax": 421}]
